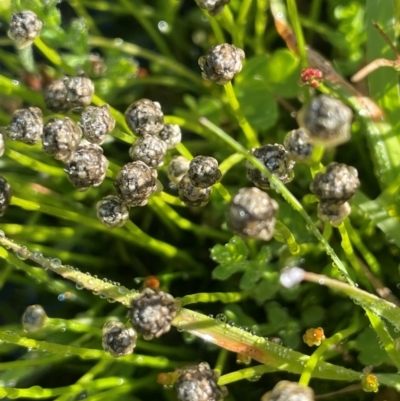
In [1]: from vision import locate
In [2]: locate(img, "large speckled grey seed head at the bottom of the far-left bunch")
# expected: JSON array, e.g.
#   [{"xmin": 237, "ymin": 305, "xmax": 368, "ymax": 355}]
[{"xmin": 64, "ymin": 144, "xmax": 108, "ymax": 191}]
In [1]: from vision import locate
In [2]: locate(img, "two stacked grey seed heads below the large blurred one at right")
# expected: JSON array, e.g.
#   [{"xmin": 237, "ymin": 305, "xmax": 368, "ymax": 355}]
[{"xmin": 310, "ymin": 162, "xmax": 360, "ymax": 225}]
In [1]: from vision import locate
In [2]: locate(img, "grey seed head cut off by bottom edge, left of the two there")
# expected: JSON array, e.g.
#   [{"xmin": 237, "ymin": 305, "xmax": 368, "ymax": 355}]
[{"xmin": 175, "ymin": 362, "xmax": 228, "ymax": 401}]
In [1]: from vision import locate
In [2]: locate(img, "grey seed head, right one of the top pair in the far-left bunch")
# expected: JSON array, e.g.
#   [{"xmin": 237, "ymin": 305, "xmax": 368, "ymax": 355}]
[{"xmin": 64, "ymin": 75, "xmax": 94, "ymax": 112}]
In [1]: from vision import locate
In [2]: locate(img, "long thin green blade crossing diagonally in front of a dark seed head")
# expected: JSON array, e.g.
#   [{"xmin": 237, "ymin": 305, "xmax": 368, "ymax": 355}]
[{"xmin": 199, "ymin": 118, "xmax": 354, "ymax": 285}]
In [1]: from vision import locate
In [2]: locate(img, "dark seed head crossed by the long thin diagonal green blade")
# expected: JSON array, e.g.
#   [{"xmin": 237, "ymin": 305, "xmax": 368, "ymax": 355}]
[{"xmin": 246, "ymin": 143, "xmax": 294, "ymax": 189}]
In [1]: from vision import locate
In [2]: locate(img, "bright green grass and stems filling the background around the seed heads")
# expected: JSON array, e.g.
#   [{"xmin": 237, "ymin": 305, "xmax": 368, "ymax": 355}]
[{"xmin": 0, "ymin": 0, "xmax": 400, "ymax": 401}]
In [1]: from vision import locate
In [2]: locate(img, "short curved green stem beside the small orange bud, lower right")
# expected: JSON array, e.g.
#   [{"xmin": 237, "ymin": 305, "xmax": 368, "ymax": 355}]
[{"xmin": 299, "ymin": 318, "xmax": 360, "ymax": 387}]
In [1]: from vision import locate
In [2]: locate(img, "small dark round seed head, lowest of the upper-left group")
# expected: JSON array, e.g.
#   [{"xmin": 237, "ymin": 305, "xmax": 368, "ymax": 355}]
[{"xmin": 96, "ymin": 195, "xmax": 129, "ymax": 228}]
